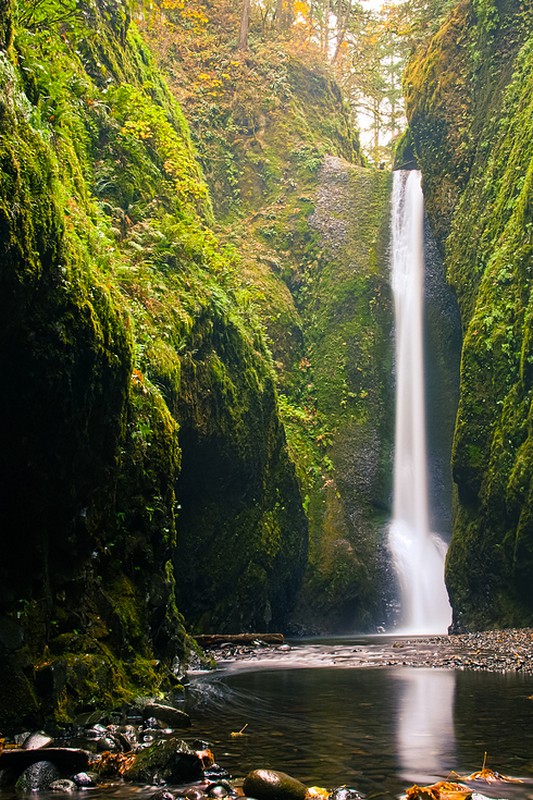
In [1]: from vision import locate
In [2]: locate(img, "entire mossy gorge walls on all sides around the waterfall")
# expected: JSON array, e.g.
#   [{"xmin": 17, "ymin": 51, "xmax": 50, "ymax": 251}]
[{"xmin": 0, "ymin": 0, "xmax": 533, "ymax": 732}]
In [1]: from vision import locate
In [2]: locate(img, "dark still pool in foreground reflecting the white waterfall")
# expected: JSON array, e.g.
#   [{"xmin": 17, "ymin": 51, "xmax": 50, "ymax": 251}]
[{"xmin": 192, "ymin": 667, "xmax": 533, "ymax": 800}]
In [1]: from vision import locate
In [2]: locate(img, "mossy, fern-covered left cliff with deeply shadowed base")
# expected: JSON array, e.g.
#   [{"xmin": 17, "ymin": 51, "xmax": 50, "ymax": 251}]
[{"xmin": 0, "ymin": 2, "xmax": 307, "ymax": 727}]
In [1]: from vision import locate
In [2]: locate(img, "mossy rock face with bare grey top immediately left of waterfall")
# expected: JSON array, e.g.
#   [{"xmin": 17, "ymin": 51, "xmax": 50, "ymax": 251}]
[{"xmin": 289, "ymin": 156, "xmax": 394, "ymax": 631}]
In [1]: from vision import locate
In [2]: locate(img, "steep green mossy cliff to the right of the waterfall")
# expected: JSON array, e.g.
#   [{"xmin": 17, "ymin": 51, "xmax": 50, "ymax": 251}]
[{"xmin": 406, "ymin": 0, "xmax": 533, "ymax": 628}]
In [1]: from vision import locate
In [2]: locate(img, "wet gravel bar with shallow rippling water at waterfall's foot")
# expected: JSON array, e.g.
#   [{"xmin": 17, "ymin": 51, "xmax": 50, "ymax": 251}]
[{"xmin": 201, "ymin": 628, "xmax": 533, "ymax": 674}]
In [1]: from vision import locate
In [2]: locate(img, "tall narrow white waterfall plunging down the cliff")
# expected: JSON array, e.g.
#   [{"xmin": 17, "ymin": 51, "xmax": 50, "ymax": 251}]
[{"xmin": 389, "ymin": 170, "xmax": 451, "ymax": 634}]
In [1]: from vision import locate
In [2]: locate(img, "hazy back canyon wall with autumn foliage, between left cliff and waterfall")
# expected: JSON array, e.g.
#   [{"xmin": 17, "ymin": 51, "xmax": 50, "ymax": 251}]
[{"xmin": 147, "ymin": 0, "xmax": 393, "ymax": 631}]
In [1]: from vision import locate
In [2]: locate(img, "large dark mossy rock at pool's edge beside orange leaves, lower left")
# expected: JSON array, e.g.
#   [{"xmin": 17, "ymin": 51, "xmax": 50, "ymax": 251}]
[{"xmin": 124, "ymin": 738, "xmax": 203, "ymax": 784}]
